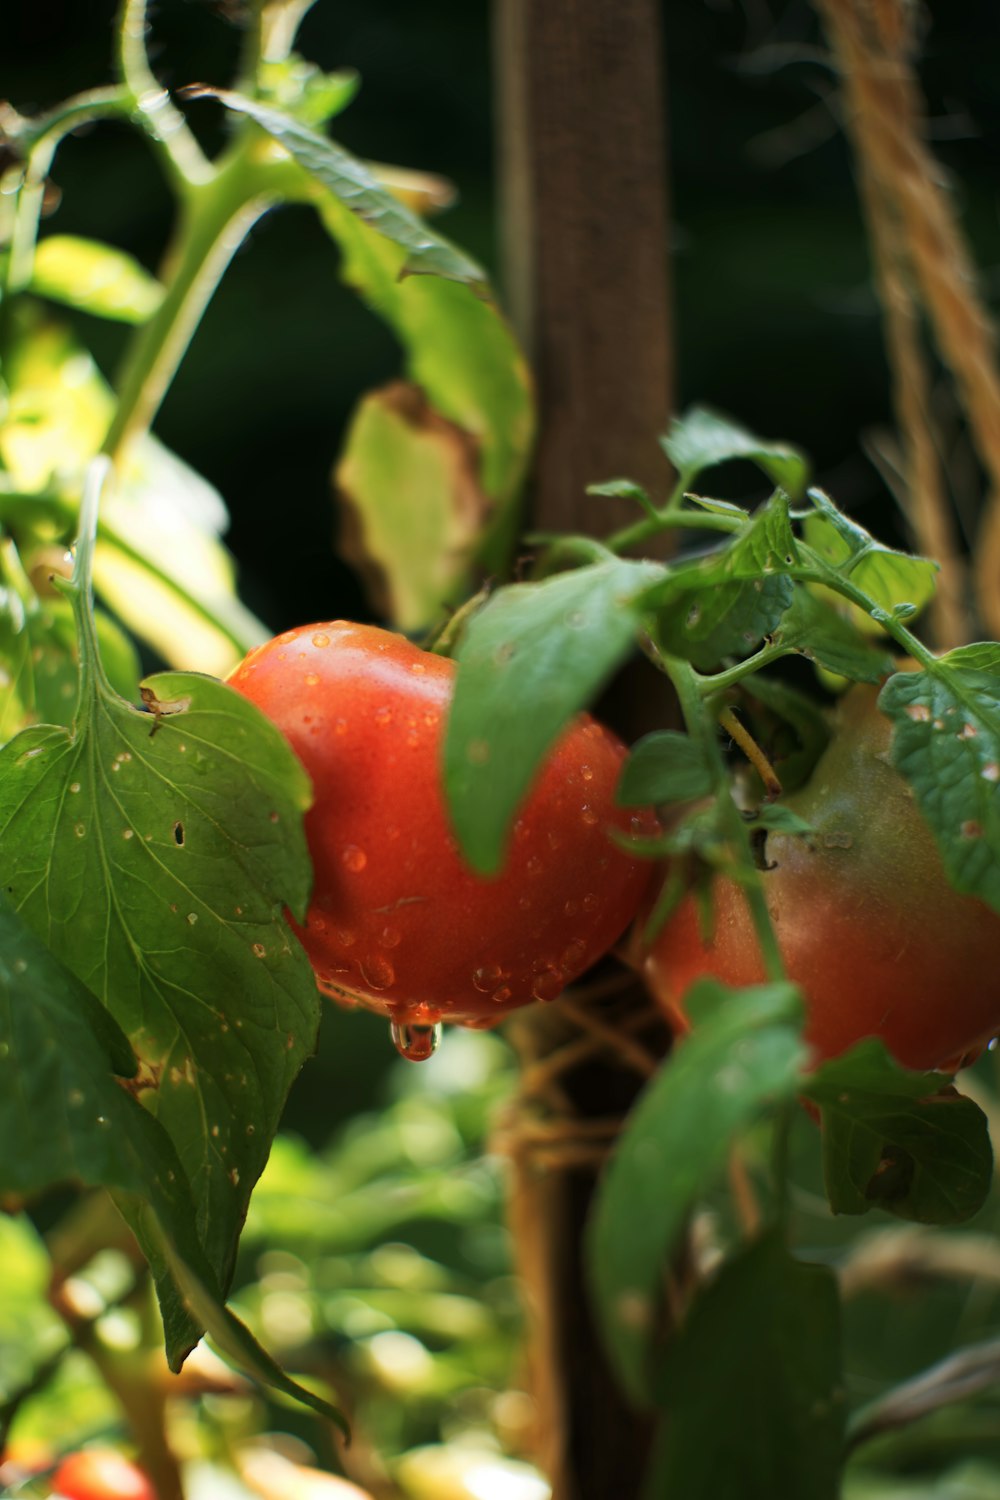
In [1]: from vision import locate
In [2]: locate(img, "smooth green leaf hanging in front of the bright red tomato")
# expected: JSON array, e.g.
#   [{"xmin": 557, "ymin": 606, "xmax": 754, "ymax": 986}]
[{"xmin": 444, "ymin": 558, "xmax": 663, "ymax": 875}]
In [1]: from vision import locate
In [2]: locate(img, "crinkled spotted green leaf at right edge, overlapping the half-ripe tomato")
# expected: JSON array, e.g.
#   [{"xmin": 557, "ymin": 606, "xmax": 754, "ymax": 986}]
[{"xmin": 879, "ymin": 669, "xmax": 1000, "ymax": 912}]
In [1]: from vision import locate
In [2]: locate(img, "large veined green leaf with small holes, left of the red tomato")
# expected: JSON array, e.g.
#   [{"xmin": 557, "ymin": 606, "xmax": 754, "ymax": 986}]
[{"xmin": 0, "ymin": 674, "xmax": 319, "ymax": 1286}]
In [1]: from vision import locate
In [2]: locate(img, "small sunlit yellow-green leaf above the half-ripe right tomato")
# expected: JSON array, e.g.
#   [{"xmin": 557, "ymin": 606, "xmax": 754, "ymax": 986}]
[{"xmin": 804, "ymin": 489, "xmax": 939, "ymax": 630}]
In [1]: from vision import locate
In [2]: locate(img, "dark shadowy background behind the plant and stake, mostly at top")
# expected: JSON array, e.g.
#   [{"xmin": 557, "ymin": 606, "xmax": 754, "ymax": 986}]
[{"xmin": 0, "ymin": 0, "xmax": 1000, "ymax": 1119}]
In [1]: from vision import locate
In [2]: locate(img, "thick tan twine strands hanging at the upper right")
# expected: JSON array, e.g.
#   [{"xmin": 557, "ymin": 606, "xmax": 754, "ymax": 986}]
[{"xmin": 814, "ymin": 0, "xmax": 1000, "ymax": 647}]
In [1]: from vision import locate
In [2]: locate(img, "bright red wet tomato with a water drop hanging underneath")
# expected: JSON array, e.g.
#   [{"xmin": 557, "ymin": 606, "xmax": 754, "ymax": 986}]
[{"xmin": 229, "ymin": 623, "xmax": 651, "ymax": 1026}]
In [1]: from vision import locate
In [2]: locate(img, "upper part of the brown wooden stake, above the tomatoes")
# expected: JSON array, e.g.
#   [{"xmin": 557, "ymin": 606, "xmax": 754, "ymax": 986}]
[{"xmin": 495, "ymin": 0, "xmax": 672, "ymax": 531}]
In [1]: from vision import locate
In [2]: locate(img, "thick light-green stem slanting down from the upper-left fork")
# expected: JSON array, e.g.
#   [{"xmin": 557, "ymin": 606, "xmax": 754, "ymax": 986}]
[{"xmin": 102, "ymin": 149, "xmax": 271, "ymax": 462}]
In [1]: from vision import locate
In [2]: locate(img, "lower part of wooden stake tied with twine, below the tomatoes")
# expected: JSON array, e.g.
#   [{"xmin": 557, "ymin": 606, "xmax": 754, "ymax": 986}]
[{"xmin": 492, "ymin": 969, "xmax": 673, "ymax": 1500}]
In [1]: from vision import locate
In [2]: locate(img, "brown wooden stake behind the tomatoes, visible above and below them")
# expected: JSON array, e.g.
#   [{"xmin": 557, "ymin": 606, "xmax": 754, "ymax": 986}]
[{"xmin": 495, "ymin": 0, "xmax": 672, "ymax": 1500}]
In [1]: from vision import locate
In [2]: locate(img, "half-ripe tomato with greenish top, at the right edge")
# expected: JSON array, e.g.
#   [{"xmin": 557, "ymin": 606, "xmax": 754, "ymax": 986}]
[{"xmin": 645, "ymin": 687, "xmax": 1000, "ymax": 1071}]
